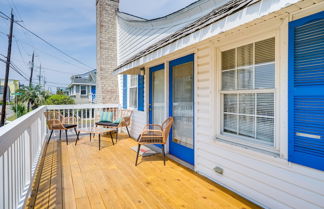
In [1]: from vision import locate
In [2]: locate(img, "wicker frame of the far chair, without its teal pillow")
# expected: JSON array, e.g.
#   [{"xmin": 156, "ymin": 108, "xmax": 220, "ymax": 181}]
[{"xmin": 96, "ymin": 109, "xmax": 133, "ymax": 142}]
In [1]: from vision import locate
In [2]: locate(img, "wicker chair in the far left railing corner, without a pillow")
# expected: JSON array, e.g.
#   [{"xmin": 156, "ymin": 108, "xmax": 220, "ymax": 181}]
[{"xmin": 44, "ymin": 111, "xmax": 78, "ymax": 144}]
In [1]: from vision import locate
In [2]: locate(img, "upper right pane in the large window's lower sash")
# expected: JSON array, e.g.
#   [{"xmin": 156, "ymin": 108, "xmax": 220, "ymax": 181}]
[{"xmin": 257, "ymin": 93, "xmax": 274, "ymax": 116}]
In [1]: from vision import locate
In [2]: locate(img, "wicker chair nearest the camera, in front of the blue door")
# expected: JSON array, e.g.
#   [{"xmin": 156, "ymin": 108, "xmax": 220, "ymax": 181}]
[{"xmin": 135, "ymin": 117, "xmax": 173, "ymax": 166}]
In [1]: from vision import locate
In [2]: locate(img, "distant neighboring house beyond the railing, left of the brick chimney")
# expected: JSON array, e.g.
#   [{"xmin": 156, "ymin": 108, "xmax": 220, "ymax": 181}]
[{"xmin": 67, "ymin": 70, "xmax": 96, "ymax": 104}]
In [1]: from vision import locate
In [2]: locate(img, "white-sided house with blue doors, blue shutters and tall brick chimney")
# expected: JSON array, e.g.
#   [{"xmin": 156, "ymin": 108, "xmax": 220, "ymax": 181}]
[{"xmin": 97, "ymin": 0, "xmax": 324, "ymax": 208}]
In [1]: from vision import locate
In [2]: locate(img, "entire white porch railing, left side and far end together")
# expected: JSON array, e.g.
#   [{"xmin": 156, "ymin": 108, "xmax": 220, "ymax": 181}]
[{"xmin": 0, "ymin": 104, "xmax": 119, "ymax": 209}]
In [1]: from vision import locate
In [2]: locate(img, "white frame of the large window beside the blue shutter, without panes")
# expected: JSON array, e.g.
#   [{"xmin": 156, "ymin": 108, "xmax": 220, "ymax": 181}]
[{"xmin": 216, "ymin": 30, "xmax": 280, "ymax": 154}]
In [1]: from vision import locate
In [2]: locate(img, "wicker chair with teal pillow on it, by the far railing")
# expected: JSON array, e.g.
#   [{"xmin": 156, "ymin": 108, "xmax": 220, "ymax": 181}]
[{"xmin": 96, "ymin": 109, "xmax": 133, "ymax": 141}]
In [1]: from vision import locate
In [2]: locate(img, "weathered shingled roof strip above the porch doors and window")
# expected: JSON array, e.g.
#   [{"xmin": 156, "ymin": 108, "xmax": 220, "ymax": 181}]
[{"xmin": 114, "ymin": 0, "xmax": 260, "ymax": 71}]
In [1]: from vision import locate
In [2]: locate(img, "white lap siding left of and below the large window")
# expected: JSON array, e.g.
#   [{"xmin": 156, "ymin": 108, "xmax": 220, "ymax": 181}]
[{"xmin": 195, "ymin": 45, "xmax": 324, "ymax": 208}]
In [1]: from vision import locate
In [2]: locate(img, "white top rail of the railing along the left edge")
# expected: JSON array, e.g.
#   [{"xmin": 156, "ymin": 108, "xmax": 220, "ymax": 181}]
[{"xmin": 0, "ymin": 106, "xmax": 46, "ymax": 156}]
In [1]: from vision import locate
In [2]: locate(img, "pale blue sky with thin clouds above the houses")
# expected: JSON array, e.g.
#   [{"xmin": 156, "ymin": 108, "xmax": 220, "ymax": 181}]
[{"xmin": 0, "ymin": 0, "xmax": 195, "ymax": 90}]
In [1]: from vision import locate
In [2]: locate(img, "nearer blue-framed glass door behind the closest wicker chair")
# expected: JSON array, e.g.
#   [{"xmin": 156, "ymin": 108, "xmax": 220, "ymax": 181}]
[{"xmin": 169, "ymin": 54, "xmax": 194, "ymax": 165}]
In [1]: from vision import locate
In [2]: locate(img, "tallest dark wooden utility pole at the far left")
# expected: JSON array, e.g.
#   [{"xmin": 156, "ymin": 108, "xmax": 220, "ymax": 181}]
[{"xmin": 0, "ymin": 10, "xmax": 14, "ymax": 126}]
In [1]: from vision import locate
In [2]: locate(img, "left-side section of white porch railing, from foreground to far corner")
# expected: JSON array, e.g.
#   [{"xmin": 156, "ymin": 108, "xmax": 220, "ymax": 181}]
[{"xmin": 0, "ymin": 106, "xmax": 46, "ymax": 209}]
